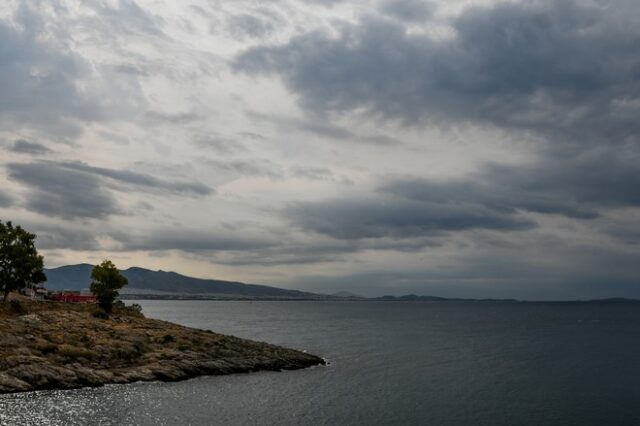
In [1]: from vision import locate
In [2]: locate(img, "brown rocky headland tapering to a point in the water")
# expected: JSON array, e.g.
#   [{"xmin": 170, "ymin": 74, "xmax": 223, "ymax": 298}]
[{"xmin": 0, "ymin": 301, "xmax": 325, "ymax": 394}]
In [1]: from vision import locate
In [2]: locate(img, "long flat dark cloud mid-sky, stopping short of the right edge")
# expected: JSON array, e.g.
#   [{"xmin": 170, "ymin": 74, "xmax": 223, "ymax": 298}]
[{"xmin": 285, "ymin": 198, "xmax": 535, "ymax": 240}]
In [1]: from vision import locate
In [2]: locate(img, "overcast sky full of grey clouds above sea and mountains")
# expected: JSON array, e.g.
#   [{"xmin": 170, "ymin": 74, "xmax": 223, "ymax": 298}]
[{"xmin": 0, "ymin": 0, "xmax": 640, "ymax": 300}]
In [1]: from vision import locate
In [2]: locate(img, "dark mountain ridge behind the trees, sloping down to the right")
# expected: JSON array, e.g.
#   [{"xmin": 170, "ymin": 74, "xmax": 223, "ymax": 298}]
[{"xmin": 45, "ymin": 263, "xmax": 328, "ymax": 300}]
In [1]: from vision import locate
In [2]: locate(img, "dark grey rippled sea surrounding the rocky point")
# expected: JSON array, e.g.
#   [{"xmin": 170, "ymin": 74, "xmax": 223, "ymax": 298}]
[{"xmin": 0, "ymin": 301, "xmax": 640, "ymax": 426}]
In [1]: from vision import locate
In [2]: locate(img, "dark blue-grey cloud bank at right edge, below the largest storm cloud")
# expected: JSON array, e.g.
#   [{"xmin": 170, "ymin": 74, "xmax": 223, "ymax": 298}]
[{"xmin": 380, "ymin": 150, "xmax": 640, "ymax": 219}]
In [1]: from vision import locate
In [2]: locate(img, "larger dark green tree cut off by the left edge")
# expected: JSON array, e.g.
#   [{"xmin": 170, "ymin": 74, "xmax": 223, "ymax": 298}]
[{"xmin": 0, "ymin": 221, "xmax": 47, "ymax": 302}]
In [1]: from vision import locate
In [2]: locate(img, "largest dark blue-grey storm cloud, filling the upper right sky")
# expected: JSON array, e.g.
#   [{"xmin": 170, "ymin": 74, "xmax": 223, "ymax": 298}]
[{"xmin": 234, "ymin": 0, "xmax": 640, "ymax": 145}]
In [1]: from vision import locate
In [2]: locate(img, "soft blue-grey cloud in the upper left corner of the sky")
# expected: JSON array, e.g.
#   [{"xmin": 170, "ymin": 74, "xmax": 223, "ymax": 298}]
[{"xmin": 0, "ymin": 5, "xmax": 101, "ymax": 136}]
